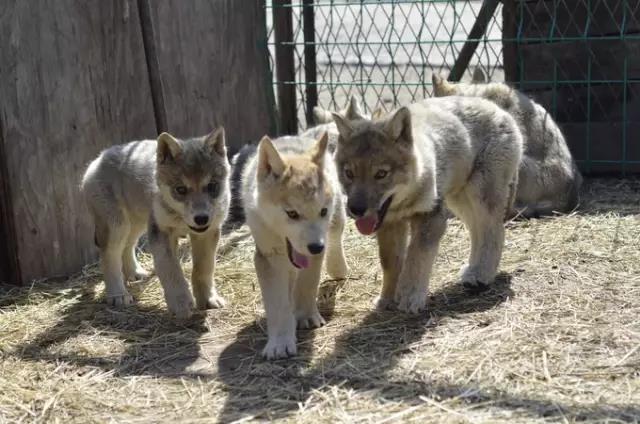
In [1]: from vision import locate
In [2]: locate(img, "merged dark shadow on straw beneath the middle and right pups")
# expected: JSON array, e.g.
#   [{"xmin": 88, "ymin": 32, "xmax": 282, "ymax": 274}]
[{"xmin": 218, "ymin": 274, "xmax": 514, "ymax": 422}]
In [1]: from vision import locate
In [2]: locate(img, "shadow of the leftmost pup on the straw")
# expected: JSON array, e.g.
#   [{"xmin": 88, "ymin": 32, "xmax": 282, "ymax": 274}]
[{"xmin": 0, "ymin": 279, "xmax": 209, "ymax": 376}]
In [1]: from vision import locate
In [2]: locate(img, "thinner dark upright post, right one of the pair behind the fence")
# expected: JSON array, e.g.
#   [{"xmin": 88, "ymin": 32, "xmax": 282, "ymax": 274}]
[{"xmin": 302, "ymin": 0, "xmax": 318, "ymax": 126}]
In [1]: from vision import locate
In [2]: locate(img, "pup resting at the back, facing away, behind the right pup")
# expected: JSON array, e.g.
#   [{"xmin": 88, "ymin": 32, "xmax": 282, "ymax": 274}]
[{"xmin": 432, "ymin": 72, "xmax": 582, "ymax": 217}]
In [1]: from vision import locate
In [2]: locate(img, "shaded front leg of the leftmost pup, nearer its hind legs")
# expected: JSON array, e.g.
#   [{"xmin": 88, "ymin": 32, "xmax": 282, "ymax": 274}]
[{"xmin": 149, "ymin": 222, "xmax": 193, "ymax": 319}]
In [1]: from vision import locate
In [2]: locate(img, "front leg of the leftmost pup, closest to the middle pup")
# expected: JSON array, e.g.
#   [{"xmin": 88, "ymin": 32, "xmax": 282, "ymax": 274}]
[{"xmin": 190, "ymin": 228, "xmax": 225, "ymax": 310}]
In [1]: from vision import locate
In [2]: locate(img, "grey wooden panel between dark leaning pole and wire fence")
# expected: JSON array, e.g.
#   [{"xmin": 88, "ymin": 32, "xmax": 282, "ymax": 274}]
[{"xmin": 150, "ymin": 0, "xmax": 275, "ymax": 152}]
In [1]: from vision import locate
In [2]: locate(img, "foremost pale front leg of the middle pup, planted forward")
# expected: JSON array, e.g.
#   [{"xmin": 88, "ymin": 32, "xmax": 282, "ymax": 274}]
[{"xmin": 254, "ymin": 248, "xmax": 297, "ymax": 359}]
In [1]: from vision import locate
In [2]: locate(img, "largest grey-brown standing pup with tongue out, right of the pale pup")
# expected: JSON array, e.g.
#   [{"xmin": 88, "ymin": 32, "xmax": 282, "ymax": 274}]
[{"xmin": 333, "ymin": 97, "xmax": 522, "ymax": 313}]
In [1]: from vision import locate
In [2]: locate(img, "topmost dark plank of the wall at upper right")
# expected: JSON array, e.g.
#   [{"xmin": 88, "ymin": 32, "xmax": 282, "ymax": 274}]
[{"xmin": 520, "ymin": 0, "xmax": 640, "ymax": 40}]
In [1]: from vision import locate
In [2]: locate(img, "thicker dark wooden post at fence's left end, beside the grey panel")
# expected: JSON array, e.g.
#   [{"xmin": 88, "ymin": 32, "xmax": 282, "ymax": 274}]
[{"xmin": 273, "ymin": 0, "xmax": 298, "ymax": 134}]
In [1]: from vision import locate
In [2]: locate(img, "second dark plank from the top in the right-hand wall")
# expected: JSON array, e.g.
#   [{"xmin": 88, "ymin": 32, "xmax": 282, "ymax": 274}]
[{"xmin": 519, "ymin": 40, "xmax": 640, "ymax": 83}]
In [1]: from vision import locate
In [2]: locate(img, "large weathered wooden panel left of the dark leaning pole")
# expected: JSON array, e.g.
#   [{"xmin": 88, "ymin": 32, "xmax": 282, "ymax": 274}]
[{"xmin": 0, "ymin": 0, "xmax": 156, "ymax": 282}]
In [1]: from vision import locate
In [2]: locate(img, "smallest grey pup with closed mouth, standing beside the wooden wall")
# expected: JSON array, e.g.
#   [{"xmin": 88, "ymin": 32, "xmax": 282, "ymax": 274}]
[{"xmin": 82, "ymin": 128, "xmax": 230, "ymax": 318}]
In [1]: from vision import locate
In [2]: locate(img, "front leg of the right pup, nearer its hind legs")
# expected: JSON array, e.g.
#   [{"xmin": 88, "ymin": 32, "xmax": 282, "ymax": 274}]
[{"xmin": 395, "ymin": 207, "xmax": 447, "ymax": 314}]
